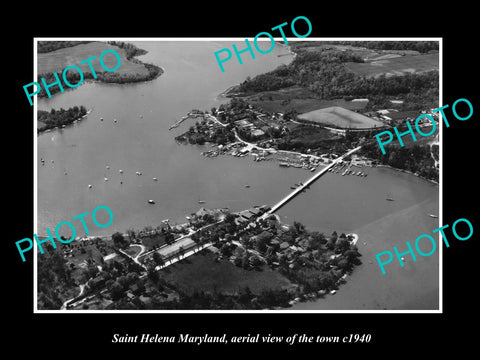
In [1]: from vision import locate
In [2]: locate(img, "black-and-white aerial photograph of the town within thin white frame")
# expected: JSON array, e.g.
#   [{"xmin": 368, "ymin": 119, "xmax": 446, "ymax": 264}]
[{"xmin": 30, "ymin": 37, "xmax": 438, "ymax": 311}]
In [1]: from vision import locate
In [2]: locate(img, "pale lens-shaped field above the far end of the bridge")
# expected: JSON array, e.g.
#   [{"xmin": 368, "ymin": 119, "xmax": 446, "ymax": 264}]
[{"xmin": 298, "ymin": 106, "xmax": 384, "ymax": 129}]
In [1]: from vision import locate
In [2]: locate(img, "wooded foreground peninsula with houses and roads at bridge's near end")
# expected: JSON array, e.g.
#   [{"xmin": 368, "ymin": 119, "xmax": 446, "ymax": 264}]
[{"xmin": 38, "ymin": 206, "xmax": 361, "ymax": 310}]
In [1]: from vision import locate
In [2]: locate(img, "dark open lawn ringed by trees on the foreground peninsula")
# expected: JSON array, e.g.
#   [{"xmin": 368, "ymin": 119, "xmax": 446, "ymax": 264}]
[{"xmin": 159, "ymin": 249, "xmax": 291, "ymax": 294}]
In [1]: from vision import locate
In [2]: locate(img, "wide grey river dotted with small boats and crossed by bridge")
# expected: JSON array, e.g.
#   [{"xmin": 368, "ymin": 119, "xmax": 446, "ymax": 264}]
[{"xmin": 37, "ymin": 41, "xmax": 438, "ymax": 309}]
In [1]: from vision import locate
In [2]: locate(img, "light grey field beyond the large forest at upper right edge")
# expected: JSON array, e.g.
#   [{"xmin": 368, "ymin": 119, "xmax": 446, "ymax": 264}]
[{"xmin": 345, "ymin": 53, "xmax": 440, "ymax": 77}]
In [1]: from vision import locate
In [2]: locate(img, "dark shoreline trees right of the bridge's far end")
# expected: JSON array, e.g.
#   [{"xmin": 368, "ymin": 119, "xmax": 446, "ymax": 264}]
[{"xmin": 360, "ymin": 142, "xmax": 438, "ymax": 182}]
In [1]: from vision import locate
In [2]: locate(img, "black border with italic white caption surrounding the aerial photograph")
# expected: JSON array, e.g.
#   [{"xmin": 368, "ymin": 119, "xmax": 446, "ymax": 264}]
[{"xmin": 7, "ymin": 3, "xmax": 480, "ymax": 357}]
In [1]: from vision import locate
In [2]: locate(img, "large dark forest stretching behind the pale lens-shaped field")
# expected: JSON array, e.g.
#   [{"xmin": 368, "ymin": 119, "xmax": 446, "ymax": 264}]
[{"xmin": 236, "ymin": 49, "xmax": 439, "ymax": 110}]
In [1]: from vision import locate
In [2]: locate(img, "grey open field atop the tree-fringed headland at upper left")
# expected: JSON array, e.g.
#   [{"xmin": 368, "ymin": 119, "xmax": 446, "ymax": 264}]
[{"xmin": 38, "ymin": 41, "xmax": 148, "ymax": 75}]
